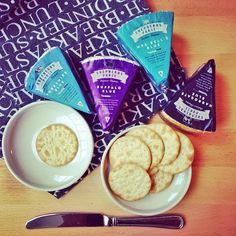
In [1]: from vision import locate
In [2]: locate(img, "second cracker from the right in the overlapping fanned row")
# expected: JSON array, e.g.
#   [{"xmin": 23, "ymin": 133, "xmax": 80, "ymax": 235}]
[{"xmin": 148, "ymin": 123, "xmax": 180, "ymax": 170}]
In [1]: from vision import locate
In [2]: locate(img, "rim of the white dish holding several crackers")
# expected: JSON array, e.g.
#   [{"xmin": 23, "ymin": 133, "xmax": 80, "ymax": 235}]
[{"xmin": 100, "ymin": 124, "xmax": 192, "ymax": 216}]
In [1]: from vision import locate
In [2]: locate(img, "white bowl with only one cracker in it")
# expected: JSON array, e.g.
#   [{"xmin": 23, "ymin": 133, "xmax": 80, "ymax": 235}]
[{"xmin": 2, "ymin": 101, "xmax": 94, "ymax": 191}]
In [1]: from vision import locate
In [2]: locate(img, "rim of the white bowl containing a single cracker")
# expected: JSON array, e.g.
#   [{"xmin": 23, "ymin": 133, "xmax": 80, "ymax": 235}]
[{"xmin": 2, "ymin": 100, "xmax": 94, "ymax": 192}]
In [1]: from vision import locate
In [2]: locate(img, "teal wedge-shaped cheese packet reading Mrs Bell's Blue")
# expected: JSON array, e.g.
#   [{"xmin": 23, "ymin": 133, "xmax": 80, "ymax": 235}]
[{"xmin": 117, "ymin": 11, "xmax": 174, "ymax": 92}]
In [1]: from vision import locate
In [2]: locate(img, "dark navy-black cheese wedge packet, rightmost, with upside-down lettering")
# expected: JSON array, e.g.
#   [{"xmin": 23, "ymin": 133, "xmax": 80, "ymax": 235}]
[{"xmin": 160, "ymin": 59, "xmax": 216, "ymax": 133}]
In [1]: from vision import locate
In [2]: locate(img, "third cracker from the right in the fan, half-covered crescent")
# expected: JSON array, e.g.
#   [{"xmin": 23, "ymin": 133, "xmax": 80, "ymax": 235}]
[{"xmin": 126, "ymin": 126, "xmax": 164, "ymax": 174}]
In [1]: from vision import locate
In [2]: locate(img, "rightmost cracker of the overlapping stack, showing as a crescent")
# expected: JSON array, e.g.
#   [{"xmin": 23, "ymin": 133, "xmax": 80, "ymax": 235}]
[{"xmin": 159, "ymin": 132, "xmax": 194, "ymax": 174}]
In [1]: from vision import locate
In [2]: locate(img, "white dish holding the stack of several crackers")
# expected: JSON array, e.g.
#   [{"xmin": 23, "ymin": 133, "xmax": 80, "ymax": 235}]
[{"xmin": 101, "ymin": 127, "xmax": 192, "ymax": 216}]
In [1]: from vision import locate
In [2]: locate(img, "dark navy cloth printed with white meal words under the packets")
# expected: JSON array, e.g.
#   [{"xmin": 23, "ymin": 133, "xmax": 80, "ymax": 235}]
[{"xmin": 0, "ymin": 0, "xmax": 185, "ymax": 198}]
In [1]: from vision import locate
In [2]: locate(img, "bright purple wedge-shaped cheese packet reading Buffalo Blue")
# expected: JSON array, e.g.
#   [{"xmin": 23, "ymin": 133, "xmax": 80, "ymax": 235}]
[{"xmin": 81, "ymin": 56, "xmax": 139, "ymax": 130}]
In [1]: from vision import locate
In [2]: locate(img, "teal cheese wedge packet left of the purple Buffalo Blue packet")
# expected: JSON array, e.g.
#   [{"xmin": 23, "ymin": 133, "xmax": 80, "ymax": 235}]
[{"xmin": 25, "ymin": 47, "xmax": 93, "ymax": 113}]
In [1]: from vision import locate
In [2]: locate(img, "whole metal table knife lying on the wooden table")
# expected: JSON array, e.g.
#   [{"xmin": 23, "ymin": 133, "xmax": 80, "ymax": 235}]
[{"xmin": 25, "ymin": 212, "xmax": 184, "ymax": 229}]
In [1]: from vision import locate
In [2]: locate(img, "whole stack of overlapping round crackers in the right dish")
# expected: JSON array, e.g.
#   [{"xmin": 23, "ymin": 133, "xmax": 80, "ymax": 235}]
[{"xmin": 108, "ymin": 123, "xmax": 194, "ymax": 201}]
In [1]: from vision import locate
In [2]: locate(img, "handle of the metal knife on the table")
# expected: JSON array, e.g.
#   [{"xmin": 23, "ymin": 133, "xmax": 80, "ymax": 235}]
[{"xmin": 112, "ymin": 214, "xmax": 185, "ymax": 229}]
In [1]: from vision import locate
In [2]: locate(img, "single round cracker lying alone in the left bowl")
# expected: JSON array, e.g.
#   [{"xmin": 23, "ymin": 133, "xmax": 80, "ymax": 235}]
[{"xmin": 36, "ymin": 124, "xmax": 79, "ymax": 166}]
